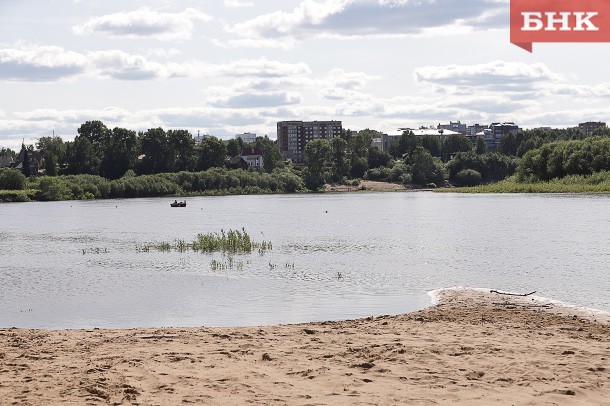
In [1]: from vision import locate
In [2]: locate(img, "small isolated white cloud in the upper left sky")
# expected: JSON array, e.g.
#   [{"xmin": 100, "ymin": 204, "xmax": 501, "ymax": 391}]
[{"xmin": 72, "ymin": 8, "xmax": 213, "ymax": 41}]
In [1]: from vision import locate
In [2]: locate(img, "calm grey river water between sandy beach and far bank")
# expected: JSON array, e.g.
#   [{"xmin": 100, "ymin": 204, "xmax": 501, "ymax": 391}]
[{"xmin": 0, "ymin": 192, "xmax": 610, "ymax": 329}]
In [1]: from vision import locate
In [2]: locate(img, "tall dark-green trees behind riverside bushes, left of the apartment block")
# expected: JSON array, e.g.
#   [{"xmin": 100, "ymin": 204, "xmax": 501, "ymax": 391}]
[{"xmin": 27, "ymin": 121, "xmax": 282, "ymax": 180}]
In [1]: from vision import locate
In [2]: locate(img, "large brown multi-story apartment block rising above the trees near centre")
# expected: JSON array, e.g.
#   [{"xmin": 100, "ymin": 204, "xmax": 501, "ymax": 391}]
[{"xmin": 277, "ymin": 120, "xmax": 343, "ymax": 163}]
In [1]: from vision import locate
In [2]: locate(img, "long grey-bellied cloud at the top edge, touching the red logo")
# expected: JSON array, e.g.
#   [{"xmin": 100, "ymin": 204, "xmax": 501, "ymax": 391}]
[{"xmin": 227, "ymin": 0, "xmax": 508, "ymax": 39}]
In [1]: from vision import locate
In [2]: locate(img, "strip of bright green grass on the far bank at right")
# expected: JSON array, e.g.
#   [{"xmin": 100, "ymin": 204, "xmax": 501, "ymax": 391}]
[{"xmin": 437, "ymin": 172, "xmax": 610, "ymax": 193}]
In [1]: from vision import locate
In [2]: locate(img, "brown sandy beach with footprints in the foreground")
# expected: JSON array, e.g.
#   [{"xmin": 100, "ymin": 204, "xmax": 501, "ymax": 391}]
[{"xmin": 0, "ymin": 289, "xmax": 610, "ymax": 405}]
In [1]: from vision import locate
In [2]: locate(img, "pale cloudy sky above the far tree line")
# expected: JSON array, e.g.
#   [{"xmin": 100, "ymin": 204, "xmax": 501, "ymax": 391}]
[{"xmin": 0, "ymin": 0, "xmax": 610, "ymax": 150}]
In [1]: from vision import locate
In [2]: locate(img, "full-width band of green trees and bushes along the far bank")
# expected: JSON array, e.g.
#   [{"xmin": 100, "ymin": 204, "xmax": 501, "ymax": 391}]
[{"xmin": 0, "ymin": 121, "xmax": 610, "ymax": 200}]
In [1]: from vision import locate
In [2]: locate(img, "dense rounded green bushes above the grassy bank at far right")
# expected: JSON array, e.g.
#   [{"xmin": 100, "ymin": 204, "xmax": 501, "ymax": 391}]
[{"xmin": 517, "ymin": 137, "xmax": 610, "ymax": 182}]
